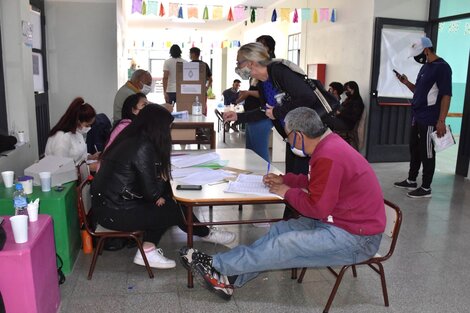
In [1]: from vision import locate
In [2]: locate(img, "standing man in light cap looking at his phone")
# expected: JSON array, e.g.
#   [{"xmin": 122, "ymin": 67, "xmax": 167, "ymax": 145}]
[{"xmin": 394, "ymin": 37, "xmax": 452, "ymax": 198}]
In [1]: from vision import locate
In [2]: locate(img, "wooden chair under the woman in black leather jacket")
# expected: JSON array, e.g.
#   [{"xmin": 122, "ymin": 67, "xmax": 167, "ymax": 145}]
[{"xmin": 77, "ymin": 176, "xmax": 154, "ymax": 280}]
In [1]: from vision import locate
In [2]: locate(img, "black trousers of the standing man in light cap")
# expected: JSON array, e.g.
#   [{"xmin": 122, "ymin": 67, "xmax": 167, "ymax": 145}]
[{"xmin": 408, "ymin": 122, "xmax": 436, "ymax": 189}]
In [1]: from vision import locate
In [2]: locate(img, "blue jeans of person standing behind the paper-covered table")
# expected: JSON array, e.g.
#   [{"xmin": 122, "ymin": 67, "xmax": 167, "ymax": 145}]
[{"xmin": 245, "ymin": 118, "xmax": 273, "ymax": 162}]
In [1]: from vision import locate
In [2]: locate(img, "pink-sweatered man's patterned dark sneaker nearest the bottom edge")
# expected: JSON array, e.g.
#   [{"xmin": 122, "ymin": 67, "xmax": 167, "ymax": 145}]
[{"xmin": 191, "ymin": 262, "xmax": 233, "ymax": 300}]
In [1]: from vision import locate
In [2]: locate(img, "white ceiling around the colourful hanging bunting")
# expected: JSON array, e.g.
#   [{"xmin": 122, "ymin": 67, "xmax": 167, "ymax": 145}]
[{"xmin": 123, "ymin": 0, "xmax": 281, "ymax": 31}]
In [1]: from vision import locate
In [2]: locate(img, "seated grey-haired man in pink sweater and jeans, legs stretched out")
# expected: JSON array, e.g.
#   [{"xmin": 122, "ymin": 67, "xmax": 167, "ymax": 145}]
[{"xmin": 180, "ymin": 107, "xmax": 385, "ymax": 299}]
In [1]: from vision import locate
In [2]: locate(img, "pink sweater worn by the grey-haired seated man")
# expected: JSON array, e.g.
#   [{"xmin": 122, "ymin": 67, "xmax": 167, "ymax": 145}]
[{"xmin": 284, "ymin": 133, "xmax": 385, "ymax": 235}]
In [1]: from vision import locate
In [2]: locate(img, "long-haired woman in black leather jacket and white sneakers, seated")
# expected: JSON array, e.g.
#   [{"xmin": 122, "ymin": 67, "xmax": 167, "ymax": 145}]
[{"xmin": 92, "ymin": 104, "xmax": 235, "ymax": 268}]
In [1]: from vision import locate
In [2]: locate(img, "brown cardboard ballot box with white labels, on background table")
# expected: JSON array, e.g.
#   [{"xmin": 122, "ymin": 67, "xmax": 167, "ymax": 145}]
[{"xmin": 176, "ymin": 62, "xmax": 207, "ymax": 114}]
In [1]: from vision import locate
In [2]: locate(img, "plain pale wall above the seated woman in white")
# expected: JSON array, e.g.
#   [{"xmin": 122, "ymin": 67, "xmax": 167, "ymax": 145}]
[{"xmin": 45, "ymin": 0, "xmax": 118, "ymax": 127}]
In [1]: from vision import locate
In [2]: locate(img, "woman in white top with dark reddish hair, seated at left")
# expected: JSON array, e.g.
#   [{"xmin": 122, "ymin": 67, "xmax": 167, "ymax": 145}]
[{"xmin": 45, "ymin": 98, "xmax": 99, "ymax": 171}]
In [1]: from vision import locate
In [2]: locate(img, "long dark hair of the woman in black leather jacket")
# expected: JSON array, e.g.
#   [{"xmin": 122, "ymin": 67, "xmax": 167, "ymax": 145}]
[{"xmin": 103, "ymin": 104, "xmax": 174, "ymax": 179}]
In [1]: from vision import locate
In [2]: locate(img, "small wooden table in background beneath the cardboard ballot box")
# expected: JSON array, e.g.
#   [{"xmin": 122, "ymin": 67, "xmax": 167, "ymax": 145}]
[{"xmin": 171, "ymin": 115, "xmax": 215, "ymax": 149}]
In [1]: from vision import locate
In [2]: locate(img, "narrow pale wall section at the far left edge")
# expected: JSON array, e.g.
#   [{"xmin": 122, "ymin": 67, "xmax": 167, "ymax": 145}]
[{"xmin": 0, "ymin": 0, "xmax": 38, "ymax": 175}]
